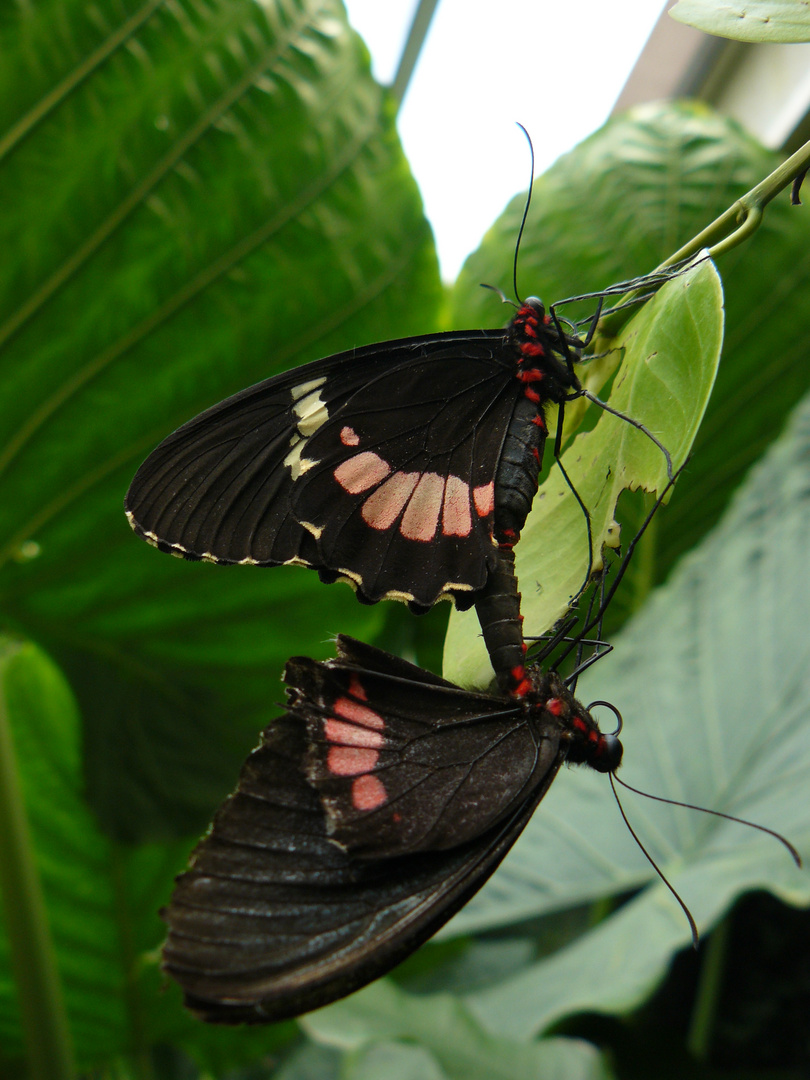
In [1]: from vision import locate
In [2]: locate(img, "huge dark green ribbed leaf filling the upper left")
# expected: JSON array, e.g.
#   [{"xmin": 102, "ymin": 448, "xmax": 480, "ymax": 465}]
[{"xmin": 0, "ymin": 0, "xmax": 440, "ymax": 838}]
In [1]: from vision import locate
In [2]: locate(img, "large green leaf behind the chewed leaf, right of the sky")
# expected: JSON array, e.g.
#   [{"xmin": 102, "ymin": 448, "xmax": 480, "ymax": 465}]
[{"xmin": 451, "ymin": 104, "xmax": 810, "ymax": 621}]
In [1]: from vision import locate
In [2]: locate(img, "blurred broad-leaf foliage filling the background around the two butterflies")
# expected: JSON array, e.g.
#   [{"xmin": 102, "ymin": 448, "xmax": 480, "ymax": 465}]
[{"xmin": 0, "ymin": 0, "xmax": 810, "ymax": 1080}]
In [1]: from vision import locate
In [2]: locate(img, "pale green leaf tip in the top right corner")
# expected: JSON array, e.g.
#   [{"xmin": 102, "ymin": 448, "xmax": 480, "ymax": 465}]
[{"xmin": 669, "ymin": 0, "xmax": 810, "ymax": 42}]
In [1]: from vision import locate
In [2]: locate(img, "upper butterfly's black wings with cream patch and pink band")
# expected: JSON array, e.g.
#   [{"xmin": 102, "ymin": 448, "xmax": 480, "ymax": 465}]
[{"xmin": 125, "ymin": 330, "xmax": 523, "ymax": 608}]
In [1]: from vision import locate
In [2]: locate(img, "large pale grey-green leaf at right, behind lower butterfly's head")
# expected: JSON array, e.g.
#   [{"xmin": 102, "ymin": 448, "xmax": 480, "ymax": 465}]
[{"xmin": 450, "ymin": 386, "xmax": 810, "ymax": 1039}]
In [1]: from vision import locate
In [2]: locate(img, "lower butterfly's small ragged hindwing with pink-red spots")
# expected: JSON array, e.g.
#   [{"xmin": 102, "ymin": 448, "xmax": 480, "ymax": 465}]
[{"xmin": 293, "ymin": 637, "xmax": 558, "ymax": 859}]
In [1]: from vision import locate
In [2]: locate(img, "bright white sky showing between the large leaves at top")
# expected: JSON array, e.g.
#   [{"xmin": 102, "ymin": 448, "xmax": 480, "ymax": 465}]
[{"xmin": 345, "ymin": 0, "xmax": 663, "ymax": 281}]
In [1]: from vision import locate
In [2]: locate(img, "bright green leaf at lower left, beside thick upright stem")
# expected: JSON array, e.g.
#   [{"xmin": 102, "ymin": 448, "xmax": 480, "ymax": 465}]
[{"xmin": 0, "ymin": 643, "xmax": 298, "ymax": 1072}]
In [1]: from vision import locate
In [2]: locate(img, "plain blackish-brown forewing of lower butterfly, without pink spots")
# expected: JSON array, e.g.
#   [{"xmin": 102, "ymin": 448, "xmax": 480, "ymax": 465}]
[{"xmin": 163, "ymin": 716, "xmax": 562, "ymax": 1024}]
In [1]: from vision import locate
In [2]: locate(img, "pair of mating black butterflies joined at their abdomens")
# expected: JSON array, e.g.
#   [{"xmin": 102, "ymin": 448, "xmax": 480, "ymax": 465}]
[{"xmin": 126, "ymin": 270, "xmax": 691, "ymax": 1023}]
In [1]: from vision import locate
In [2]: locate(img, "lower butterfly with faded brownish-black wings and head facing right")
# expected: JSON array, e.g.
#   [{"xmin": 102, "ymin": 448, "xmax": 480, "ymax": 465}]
[{"xmin": 161, "ymin": 636, "xmax": 622, "ymax": 1024}]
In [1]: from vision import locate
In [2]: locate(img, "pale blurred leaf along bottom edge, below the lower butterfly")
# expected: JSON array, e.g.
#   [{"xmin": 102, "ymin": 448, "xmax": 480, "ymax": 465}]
[{"xmin": 301, "ymin": 978, "xmax": 609, "ymax": 1080}]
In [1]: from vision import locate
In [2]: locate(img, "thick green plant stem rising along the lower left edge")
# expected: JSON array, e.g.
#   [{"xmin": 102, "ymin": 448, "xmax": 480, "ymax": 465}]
[{"xmin": 0, "ymin": 643, "xmax": 75, "ymax": 1080}]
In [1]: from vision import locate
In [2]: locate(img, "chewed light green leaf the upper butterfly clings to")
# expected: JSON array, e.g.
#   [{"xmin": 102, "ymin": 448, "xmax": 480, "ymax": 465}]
[{"xmin": 445, "ymin": 259, "xmax": 723, "ymax": 687}]
